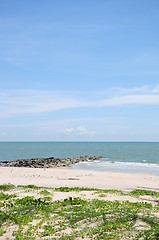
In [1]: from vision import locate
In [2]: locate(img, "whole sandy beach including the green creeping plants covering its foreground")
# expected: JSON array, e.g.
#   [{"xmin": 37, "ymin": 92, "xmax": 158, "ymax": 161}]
[{"xmin": 0, "ymin": 167, "xmax": 159, "ymax": 240}]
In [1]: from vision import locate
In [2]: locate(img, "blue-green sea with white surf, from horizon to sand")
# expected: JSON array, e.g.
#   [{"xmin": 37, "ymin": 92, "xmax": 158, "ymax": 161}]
[{"xmin": 0, "ymin": 142, "xmax": 159, "ymax": 175}]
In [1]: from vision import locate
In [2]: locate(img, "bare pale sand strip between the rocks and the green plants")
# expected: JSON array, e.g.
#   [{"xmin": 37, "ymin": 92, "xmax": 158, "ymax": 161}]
[{"xmin": 0, "ymin": 167, "xmax": 159, "ymax": 191}]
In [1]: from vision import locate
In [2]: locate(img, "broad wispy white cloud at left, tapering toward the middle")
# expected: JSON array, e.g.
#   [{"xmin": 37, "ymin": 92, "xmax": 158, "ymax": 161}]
[{"xmin": 0, "ymin": 90, "xmax": 86, "ymax": 117}]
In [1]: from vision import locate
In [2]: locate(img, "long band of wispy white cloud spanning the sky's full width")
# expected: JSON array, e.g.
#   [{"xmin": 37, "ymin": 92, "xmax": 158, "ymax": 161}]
[{"xmin": 0, "ymin": 85, "xmax": 159, "ymax": 118}]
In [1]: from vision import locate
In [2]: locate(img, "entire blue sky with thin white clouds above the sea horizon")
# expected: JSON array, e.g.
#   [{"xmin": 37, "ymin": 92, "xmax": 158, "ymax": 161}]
[{"xmin": 0, "ymin": 0, "xmax": 159, "ymax": 142}]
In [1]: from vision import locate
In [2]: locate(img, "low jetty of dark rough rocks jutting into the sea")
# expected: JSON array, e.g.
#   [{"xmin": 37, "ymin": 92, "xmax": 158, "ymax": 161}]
[{"xmin": 0, "ymin": 156, "xmax": 102, "ymax": 168}]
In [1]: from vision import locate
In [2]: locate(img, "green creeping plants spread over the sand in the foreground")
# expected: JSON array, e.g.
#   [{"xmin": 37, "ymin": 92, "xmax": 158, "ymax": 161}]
[{"xmin": 0, "ymin": 185, "xmax": 159, "ymax": 240}]
